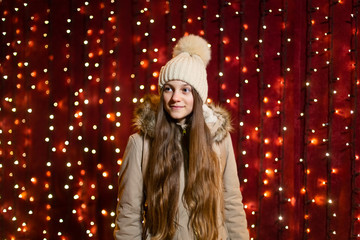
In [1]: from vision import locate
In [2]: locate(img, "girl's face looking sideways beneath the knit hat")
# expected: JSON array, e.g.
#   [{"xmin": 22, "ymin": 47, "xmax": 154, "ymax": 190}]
[{"xmin": 163, "ymin": 80, "xmax": 194, "ymax": 123}]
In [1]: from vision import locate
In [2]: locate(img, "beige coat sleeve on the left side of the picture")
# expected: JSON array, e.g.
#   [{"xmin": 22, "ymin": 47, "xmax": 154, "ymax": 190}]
[{"xmin": 114, "ymin": 134, "xmax": 143, "ymax": 240}]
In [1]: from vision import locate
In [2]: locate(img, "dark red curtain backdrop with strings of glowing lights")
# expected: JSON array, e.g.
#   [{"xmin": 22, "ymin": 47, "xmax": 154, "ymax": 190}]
[{"xmin": 0, "ymin": 0, "xmax": 360, "ymax": 239}]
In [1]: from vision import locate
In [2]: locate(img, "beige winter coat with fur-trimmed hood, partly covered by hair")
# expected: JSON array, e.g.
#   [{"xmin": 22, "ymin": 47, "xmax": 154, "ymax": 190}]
[{"xmin": 114, "ymin": 96, "xmax": 249, "ymax": 240}]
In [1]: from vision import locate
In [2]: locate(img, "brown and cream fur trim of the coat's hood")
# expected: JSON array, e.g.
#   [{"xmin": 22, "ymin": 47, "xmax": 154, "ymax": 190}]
[{"xmin": 133, "ymin": 95, "xmax": 232, "ymax": 142}]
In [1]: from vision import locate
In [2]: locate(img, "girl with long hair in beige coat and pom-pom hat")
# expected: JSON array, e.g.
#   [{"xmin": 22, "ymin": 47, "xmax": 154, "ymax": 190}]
[{"xmin": 114, "ymin": 35, "xmax": 249, "ymax": 240}]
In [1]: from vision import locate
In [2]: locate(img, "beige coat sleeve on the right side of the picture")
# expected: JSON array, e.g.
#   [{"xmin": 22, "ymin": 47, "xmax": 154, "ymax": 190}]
[{"xmin": 223, "ymin": 134, "xmax": 249, "ymax": 240}]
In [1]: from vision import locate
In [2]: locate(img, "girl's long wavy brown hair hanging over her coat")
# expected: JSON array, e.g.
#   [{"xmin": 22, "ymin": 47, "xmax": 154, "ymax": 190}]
[{"xmin": 144, "ymin": 90, "xmax": 223, "ymax": 240}]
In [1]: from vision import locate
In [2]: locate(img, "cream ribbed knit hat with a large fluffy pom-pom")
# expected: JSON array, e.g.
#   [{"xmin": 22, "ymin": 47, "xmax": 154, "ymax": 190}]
[{"xmin": 159, "ymin": 35, "xmax": 211, "ymax": 103}]
